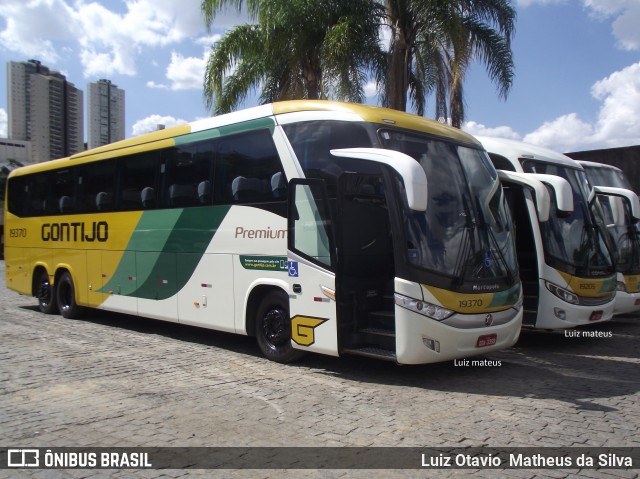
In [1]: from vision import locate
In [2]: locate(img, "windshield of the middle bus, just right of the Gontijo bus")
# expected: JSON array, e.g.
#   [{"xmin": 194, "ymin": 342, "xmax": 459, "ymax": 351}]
[{"xmin": 522, "ymin": 159, "xmax": 614, "ymax": 278}]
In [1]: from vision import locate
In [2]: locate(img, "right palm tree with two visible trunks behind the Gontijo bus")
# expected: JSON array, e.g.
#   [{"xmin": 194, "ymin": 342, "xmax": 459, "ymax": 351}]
[{"xmin": 383, "ymin": 0, "xmax": 516, "ymax": 127}]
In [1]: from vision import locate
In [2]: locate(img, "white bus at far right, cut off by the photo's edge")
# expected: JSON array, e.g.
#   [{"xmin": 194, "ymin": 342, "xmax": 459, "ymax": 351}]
[{"xmin": 579, "ymin": 161, "xmax": 640, "ymax": 314}]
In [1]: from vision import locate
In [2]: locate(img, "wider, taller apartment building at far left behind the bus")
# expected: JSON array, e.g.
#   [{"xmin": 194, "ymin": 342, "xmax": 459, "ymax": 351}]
[{"xmin": 7, "ymin": 60, "xmax": 84, "ymax": 162}]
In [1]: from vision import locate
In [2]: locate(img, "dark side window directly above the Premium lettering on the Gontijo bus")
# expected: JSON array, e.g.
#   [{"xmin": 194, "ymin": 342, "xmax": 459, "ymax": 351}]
[{"xmin": 214, "ymin": 130, "xmax": 287, "ymax": 204}]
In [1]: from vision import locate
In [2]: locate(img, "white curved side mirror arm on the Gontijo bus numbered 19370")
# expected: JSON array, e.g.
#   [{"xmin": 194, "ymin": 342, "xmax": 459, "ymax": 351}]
[{"xmin": 331, "ymin": 148, "xmax": 429, "ymax": 211}]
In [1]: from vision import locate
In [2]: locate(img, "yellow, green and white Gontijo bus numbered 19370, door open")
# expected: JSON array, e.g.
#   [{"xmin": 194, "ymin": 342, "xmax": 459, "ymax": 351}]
[{"xmin": 5, "ymin": 101, "xmax": 522, "ymax": 364}]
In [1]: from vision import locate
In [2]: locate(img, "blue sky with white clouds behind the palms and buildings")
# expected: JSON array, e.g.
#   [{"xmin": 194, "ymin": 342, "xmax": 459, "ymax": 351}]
[{"xmin": 0, "ymin": 0, "xmax": 640, "ymax": 151}]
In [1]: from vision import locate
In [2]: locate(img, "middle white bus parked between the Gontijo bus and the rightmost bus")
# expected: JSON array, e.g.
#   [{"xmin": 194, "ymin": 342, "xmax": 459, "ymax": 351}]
[{"xmin": 478, "ymin": 137, "xmax": 632, "ymax": 329}]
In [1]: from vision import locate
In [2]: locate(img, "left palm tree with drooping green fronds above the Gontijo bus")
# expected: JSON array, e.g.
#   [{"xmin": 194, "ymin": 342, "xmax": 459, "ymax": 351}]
[{"xmin": 201, "ymin": 0, "xmax": 384, "ymax": 113}]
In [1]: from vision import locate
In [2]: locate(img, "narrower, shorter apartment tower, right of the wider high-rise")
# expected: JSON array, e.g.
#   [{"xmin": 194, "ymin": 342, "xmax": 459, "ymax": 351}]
[{"xmin": 87, "ymin": 80, "xmax": 125, "ymax": 149}]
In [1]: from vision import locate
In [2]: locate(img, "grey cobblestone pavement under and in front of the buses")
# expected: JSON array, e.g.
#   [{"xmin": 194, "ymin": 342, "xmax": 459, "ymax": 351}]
[{"xmin": 0, "ymin": 262, "xmax": 640, "ymax": 478}]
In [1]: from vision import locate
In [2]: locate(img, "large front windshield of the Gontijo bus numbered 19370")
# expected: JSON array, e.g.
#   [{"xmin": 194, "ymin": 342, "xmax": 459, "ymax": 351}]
[{"xmin": 380, "ymin": 130, "xmax": 517, "ymax": 291}]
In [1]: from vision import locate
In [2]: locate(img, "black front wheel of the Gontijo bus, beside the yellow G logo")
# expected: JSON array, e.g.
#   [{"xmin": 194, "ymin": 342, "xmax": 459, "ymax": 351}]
[{"xmin": 256, "ymin": 289, "xmax": 304, "ymax": 363}]
